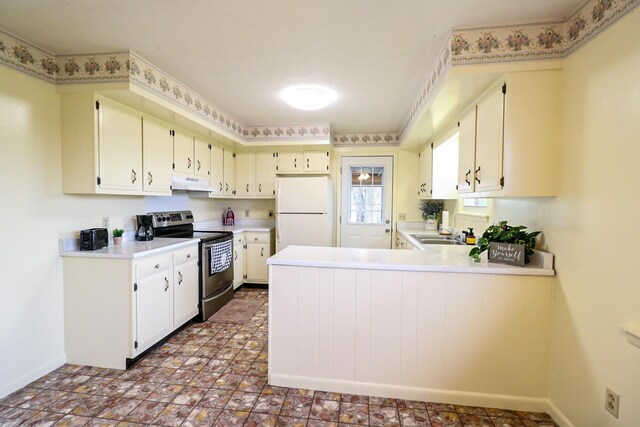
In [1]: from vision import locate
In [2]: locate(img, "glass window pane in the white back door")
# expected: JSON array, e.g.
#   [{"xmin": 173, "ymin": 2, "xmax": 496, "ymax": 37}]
[{"xmin": 349, "ymin": 166, "xmax": 384, "ymax": 225}]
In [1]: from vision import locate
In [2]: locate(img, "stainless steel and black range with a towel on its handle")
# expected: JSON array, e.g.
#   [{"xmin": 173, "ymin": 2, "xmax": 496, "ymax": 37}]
[{"xmin": 149, "ymin": 211, "xmax": 233, "ymax": 321}]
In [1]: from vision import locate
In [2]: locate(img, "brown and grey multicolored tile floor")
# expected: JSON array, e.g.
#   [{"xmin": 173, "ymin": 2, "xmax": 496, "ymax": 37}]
[{"xmin": 0, "ymin": 288, "xmax": 556, "ymax": 427}]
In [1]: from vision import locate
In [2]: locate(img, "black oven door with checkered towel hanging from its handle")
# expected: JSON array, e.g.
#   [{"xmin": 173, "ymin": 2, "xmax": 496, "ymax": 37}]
[{"xmin": 200, "ymin": 235, "xmax": 233, "ymax": 299}]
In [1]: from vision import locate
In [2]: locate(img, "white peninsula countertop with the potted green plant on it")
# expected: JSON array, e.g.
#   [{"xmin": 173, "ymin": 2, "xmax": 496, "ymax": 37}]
[{"xmin": 267, "ymin": 245, "xmax": 555, "ymax": 276}]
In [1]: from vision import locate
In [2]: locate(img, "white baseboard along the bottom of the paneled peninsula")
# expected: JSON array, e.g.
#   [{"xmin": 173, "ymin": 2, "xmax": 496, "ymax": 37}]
[{"xmin": 269, "ymin": 374, "xmax": 552, "ymax": 412}]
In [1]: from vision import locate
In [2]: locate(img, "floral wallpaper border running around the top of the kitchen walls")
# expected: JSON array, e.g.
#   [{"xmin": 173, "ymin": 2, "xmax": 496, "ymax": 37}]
[{"xmin": 0, "ymin": 0, "xmax": 640, "ymax": 146}]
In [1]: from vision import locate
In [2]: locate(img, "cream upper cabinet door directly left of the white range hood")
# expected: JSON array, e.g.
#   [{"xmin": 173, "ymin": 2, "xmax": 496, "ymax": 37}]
[{"xmin": 142, "ymin": 117, "xmax": 173, "ymax": 195}]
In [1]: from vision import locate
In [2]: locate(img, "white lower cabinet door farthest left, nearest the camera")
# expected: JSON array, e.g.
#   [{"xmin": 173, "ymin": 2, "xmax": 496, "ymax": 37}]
[{"xmin": 136, "ymin": 269, "xmax": 173, "ymax": 353}]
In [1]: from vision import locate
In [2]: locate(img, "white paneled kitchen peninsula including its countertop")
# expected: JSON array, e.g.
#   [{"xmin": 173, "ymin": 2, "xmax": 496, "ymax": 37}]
[{"xmin": 268, "ymin": 245, "xmax": 554, "ymax": 410}]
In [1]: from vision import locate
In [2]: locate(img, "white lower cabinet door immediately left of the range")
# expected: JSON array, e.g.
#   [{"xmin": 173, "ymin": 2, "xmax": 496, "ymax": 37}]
[{"xmin": 173, "ymin": 260, "xmax": 198, "ymax": 328}]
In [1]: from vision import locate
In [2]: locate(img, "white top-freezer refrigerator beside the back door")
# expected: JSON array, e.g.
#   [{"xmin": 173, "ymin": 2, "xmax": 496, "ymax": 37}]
[{"xmin": 276, "ymin": 176, "xmax": 335, "ymax": 252}]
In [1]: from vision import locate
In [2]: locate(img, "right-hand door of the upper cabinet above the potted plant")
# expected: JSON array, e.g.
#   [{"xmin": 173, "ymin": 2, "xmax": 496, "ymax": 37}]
[{"xmin": 474, "ymin": 87, "xmax": 504, "ymax": 191}]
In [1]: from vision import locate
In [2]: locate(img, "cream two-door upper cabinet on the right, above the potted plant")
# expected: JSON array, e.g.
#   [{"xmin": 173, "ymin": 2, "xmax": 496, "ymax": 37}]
[{"xmin": 458, "ymin": 70, "xmax": 562, "ymax": 197}]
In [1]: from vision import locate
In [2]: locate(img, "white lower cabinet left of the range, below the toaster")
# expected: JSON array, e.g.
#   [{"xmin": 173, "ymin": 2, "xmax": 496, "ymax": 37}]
[{"xmin": 63, "ymin": 242, "xmax": 199, "ymax": 369}]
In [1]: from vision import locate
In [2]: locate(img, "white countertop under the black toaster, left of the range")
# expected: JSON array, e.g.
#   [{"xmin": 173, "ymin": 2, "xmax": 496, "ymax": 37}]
[{"xmin": 60, "ymin": 237, "xmax": 199, "ymax": 258}]
